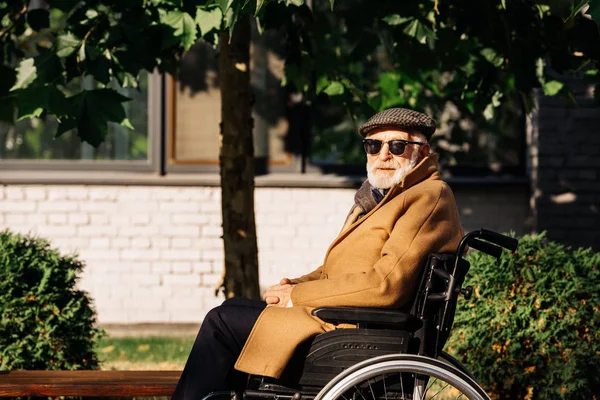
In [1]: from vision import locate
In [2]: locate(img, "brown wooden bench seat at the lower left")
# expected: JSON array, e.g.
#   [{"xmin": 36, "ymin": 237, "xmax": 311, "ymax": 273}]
[{"xmin": 0, "ymin": 371, "xmax": 181, "ymax": 397}]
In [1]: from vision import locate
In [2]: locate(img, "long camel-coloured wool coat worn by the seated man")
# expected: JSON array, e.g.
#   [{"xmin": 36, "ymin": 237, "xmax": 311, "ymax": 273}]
[{"xmin": 235, "ymin": 154, "xmax": 463, "ymax": 378}]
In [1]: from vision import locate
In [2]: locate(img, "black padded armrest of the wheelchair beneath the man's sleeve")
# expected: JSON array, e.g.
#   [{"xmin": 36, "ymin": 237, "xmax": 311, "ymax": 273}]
[{"xmin": 312, "ymin": 307, "xmax": 419, "ymax": 328}]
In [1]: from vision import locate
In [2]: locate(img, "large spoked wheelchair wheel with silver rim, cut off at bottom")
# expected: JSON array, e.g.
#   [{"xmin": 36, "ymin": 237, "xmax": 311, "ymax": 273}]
[{"xmin": 314, "ymin": 354, "xmax": 489, "ymax": 400}]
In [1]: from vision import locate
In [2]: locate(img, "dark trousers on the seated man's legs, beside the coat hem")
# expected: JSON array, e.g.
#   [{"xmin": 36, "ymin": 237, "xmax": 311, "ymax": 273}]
[{"xmin": 171, "ymin": 298, "xmax": 266, "ymax": 400}]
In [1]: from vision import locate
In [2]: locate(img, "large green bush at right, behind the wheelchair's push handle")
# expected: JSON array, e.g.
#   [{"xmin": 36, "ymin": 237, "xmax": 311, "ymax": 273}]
[{"xmin": 447, "ymin": 234, "xmax": 600, "ymax": 399}]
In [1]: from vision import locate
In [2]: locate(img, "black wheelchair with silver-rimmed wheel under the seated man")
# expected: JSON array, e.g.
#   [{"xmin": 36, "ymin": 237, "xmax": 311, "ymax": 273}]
[{"xmin": 203, "ymin": 229, "xmax": 517, "ymax": 400}]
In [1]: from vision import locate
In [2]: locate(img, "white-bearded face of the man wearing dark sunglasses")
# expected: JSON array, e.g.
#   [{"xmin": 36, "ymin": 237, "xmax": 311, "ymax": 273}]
[{"xmin": 367, "ymin": 130, "xmax": 429, "ymax": 189}]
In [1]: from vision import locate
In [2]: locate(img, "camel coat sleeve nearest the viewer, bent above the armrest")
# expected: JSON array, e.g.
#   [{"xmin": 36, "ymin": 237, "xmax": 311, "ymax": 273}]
[{"xmin": 291, "ymin": 183, "xmax": 462, "ymax": 307}]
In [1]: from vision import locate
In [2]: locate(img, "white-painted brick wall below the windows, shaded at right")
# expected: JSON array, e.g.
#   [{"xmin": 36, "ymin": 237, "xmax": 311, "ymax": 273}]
[{"xmin": 0, "ymin": 185, "xmax": 528, "ymax": 323}]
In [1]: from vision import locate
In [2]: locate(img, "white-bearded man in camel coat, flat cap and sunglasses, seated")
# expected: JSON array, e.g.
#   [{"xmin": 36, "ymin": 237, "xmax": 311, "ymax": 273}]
[{"xmin": 172, "ymin": 108, "xmax": 463, "ymax": 399}]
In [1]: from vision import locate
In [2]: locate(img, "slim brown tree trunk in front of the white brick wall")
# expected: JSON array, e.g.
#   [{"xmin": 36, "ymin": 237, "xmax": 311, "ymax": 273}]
[{"xmin": 219, "ymin": 15, "xmax": 260, "ymax": 299}]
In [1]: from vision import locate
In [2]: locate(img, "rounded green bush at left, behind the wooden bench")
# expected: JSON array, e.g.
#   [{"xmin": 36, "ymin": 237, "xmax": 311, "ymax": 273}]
[{"xmin": 0, "ymin": 231, "xmax": 101, "ymax": 370}]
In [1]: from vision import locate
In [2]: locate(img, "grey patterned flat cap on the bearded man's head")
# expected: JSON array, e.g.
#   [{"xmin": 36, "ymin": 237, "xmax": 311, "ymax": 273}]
[{"xmin": 358, "ymin": 108, "xmax": 436, "ymax": 140}]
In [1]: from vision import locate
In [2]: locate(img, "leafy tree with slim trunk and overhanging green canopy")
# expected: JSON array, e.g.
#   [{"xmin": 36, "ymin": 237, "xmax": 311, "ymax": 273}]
[{"xmin": 0, "ymin": 0, "xmax": 600, "ymax": 297}]
